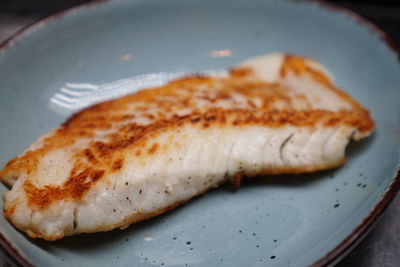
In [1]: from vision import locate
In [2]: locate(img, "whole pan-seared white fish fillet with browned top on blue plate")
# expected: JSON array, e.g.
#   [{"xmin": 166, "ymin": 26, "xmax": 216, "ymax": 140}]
[{"xmin": 0, "ymin": 54, "xmax": 374, "ymax": 240}]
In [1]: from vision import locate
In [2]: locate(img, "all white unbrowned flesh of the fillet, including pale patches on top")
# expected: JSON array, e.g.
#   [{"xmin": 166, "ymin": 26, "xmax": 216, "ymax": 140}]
[{"xmin": 3, "ymin": 54, "xmax": 369, "ymax": 240}]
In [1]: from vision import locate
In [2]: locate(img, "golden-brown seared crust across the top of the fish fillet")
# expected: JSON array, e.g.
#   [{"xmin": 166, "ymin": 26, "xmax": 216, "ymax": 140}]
[{"xmin": 0, "ymin": 56, "xmax": 374, "ymax": 215}]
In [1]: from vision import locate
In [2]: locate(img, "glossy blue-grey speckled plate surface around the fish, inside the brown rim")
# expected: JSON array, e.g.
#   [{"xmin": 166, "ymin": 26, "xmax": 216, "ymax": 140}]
[{"xmin": 0, "ymin": 0, "xmax": 400, "ymax": 266}]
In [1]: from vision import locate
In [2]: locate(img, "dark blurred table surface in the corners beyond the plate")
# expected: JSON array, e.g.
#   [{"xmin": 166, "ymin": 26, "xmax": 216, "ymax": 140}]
[{"xmin": 0, "ymin": 0, "xmax": 400, "ymax": 267}]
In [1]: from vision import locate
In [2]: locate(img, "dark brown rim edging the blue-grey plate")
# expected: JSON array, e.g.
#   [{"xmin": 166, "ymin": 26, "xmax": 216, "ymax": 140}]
[{"xmin": 0, "ymin": 0, "xmax": 400, "ymax": 266}]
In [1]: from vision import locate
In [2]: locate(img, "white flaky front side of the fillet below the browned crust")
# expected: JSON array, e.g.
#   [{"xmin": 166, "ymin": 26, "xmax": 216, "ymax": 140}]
[{"xmin": 6, "ymin": 127, "xmax": 353, "ymax": 239}]
